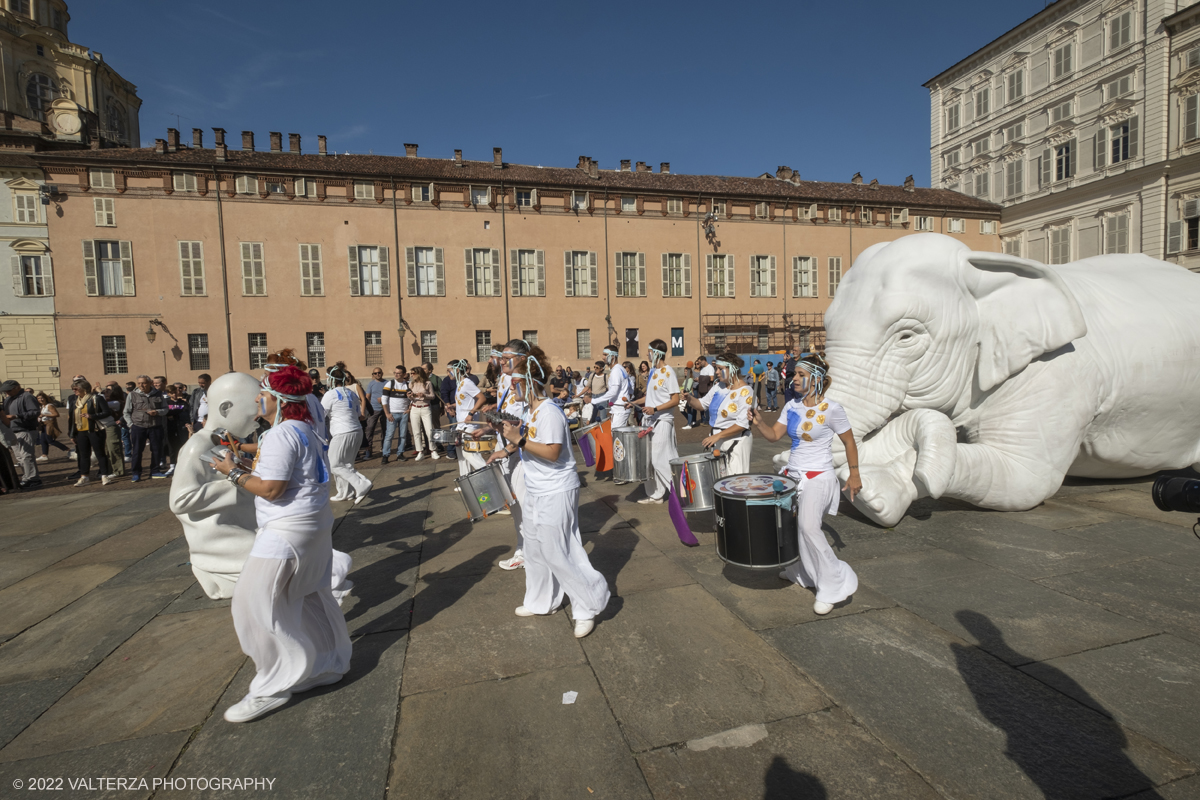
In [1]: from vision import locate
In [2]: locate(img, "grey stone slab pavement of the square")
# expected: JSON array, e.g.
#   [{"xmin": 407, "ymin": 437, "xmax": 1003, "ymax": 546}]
[{"xmin": 0, "ymin": 422, "xmax": 1200, "ymax": 800}]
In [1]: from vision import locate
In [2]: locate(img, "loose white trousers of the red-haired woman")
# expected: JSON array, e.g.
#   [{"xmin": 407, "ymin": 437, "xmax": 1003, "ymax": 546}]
[{"xmin": 232, "ymin": 505, "xmax": 350, "ymax": 697}]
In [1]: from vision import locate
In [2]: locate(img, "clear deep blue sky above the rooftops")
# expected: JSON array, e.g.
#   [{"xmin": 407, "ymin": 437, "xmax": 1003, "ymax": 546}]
[{"xmin": 70, "ymin": 0, "xmax": 1046, "ymax": 186}]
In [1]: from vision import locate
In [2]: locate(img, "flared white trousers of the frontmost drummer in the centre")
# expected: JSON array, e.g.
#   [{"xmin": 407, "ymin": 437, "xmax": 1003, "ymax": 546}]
[{"xmin": 523, "ymin": 488, "xmax": 611, "ymax": 620}]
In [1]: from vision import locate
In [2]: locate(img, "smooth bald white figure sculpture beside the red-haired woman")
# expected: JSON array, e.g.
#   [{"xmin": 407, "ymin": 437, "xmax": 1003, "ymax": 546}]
[{"xmin": 170, "ymin": 372, "xmax": 259, "ymax": 600}]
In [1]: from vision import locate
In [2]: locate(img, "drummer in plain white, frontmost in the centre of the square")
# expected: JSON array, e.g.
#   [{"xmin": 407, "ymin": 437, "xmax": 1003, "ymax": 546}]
[{"xmin": 504, "ymin": 347, "xmax": 610, "ymax": 638}]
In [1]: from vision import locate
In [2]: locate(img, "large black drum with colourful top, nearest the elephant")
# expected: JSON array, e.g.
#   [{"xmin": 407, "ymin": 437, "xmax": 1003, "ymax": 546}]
[{"xmin": 713, "ymin": 475, "xmax": 800, "ymax": 570}]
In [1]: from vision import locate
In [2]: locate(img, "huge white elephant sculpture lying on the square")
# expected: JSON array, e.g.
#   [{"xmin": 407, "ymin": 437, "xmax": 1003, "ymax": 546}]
[{"xmin": 826, "ymin": 234, "xmax": 1200, "ymax": 525}]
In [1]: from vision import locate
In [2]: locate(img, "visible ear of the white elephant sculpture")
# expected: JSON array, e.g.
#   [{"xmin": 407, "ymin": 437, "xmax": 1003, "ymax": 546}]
[{"xmin": 964, "ymin": 252, "xmax": 1087, "ymax": 391}]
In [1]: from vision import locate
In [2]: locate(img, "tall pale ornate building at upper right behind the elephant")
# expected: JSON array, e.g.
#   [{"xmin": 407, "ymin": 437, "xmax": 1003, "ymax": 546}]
[{"xmin": 925, "ymin": 0, "xmax": 1200, "ymax": 270}]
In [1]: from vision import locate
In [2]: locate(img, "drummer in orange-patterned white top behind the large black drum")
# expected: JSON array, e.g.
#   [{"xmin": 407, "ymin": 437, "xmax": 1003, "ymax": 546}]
[{"xmin": 754, "ymin": 355, "xmax": 863, "ymax": 614}]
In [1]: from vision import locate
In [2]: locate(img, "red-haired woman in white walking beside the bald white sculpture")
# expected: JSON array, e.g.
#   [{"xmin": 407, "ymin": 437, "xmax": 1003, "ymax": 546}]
[{"xmin": 214, "ymin": 365, "xmax": 350, "ymax": 722}]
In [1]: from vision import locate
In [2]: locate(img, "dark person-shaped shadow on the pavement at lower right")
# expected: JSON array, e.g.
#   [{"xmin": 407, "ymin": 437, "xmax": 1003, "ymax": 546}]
[{"xmin": 950, "ymin": 610, "xmax": 1162, "ymax": 800}]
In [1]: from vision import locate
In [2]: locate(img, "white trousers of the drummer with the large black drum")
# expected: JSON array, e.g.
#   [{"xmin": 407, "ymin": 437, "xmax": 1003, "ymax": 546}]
[{"xmin": 785, "ymin": 470, "xmax": 858, "ymax": 603}]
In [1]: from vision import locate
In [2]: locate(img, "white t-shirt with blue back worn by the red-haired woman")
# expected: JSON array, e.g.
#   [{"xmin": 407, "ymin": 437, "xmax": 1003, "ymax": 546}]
[{"xmin": 254, "ymin": 420, "xmax": 329, "ymax": 528}]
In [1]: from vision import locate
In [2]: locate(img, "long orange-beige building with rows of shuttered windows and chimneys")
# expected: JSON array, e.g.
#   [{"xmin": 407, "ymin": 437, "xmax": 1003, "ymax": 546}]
[{"xmin": 36, "ymin": 130, "xmax": 1000, "ymax": 393}]
